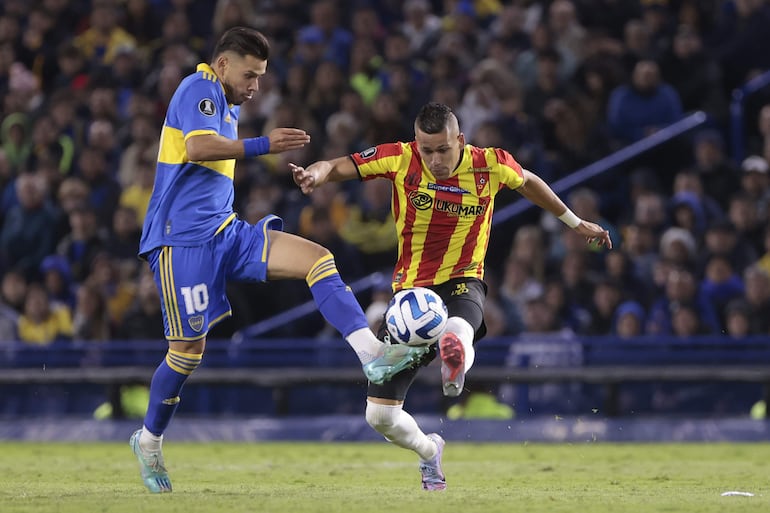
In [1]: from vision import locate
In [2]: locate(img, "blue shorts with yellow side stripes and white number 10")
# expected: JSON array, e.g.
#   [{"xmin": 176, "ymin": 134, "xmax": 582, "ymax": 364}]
[{"xmin": 146, "ymin": 215, "xmax": 283, "ymax": 340}]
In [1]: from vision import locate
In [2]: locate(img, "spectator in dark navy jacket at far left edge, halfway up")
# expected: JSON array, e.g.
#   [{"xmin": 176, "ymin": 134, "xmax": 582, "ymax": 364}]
[{"xmin": 0, "ymin": 173, "xmax": 57, "ymax": 278}]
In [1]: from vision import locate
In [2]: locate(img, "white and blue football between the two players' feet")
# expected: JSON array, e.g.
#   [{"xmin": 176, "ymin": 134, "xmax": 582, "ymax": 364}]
[{"xmin": 385, "ymin": 287, "xmax": 448, "ymax": 346}]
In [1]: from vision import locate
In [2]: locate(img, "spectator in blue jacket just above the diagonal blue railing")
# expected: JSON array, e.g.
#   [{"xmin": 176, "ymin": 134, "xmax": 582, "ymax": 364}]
[{"xmin": 607, "ymin": 59, "xmax": 682, "ymax": 145}]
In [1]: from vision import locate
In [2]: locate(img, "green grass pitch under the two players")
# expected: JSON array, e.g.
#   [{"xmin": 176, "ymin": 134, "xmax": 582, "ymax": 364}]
[{"xmin": 0, "ymin": 441, "xmax": 770, "ymax": 513}]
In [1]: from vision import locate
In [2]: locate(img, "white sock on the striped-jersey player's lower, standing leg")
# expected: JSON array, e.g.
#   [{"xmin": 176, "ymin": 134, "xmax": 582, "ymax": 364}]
[{"xmin": 366, "ymin": 400, "xmax": 438, "ymax": 460}]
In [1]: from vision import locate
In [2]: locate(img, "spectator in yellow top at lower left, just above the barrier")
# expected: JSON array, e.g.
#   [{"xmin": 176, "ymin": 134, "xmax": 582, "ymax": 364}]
[{"xmin": 19, "ymin": 284, "xmax": 73, "ymax": 346}]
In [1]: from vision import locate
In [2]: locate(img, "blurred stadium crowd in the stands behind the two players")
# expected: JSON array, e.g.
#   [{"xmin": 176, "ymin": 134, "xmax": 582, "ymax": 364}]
[{"xmin": 0, "ymin": 0, "xmax": 770, "ymax": 345}]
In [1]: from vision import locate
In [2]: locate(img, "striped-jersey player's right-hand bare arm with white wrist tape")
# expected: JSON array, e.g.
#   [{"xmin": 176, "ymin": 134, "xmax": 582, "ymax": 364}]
[{"xmin": 516, "ymin": 169, "xmax": 612, "ymax": 249}]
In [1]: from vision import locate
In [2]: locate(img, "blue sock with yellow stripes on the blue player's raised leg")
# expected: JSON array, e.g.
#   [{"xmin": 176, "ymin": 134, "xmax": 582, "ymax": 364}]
[{"xmin": 305, "ymin": 254, "xmax": 369, "ymax": 338}]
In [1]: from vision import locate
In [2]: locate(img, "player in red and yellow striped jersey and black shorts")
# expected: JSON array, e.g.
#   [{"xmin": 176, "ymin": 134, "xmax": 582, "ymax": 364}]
[{"xmin": 291, "ymin": 103, "xmax": 612, "ymax": 490}]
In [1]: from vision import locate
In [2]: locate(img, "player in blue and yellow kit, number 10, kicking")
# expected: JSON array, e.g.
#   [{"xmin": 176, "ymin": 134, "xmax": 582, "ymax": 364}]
[{"xmin": 130, "ymin": 27, "xmax": 426, "ymax": 493}]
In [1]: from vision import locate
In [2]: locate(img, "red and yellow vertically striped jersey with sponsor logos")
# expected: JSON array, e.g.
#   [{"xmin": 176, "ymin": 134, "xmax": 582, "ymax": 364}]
[{"xmin": 350, "ymin": 142, "xmax": 523, "ymax": 291}]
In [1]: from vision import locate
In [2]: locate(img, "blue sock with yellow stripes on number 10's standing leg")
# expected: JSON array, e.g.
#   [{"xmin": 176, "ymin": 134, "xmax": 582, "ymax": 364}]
[{"xmin": 144, "ymin": 349, "xmax": 203, "ymax": 436}]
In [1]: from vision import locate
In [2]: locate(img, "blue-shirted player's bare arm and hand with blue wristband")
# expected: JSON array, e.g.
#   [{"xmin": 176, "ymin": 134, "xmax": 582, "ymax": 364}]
[{"xmin": 185, "ymin": 128, "xmax": 310, "ymax": 162}]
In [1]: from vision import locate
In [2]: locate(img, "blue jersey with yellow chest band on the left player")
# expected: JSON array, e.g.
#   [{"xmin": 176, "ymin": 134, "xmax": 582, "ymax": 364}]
[{"xmin": 139, "ymin": 64, "xmax": 240, "ymax": 255}]
